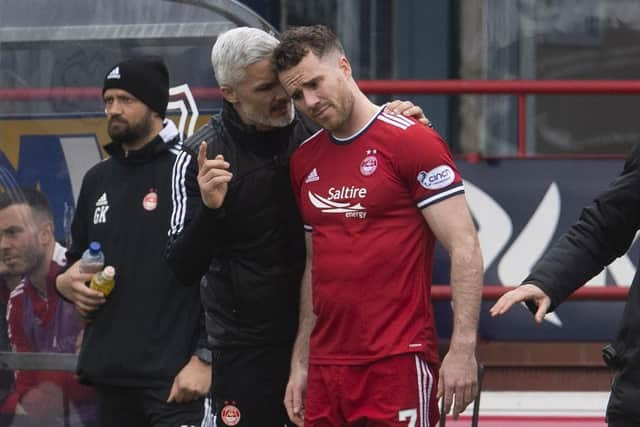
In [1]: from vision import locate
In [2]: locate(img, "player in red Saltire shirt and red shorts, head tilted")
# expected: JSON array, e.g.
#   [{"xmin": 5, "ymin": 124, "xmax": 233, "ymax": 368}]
[{"xmin": 274, "ymin": 26, "xmax": 483, "ymax": 427}]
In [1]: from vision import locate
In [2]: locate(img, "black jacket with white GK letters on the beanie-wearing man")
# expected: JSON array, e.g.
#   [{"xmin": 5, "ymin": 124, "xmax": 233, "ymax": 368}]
[{"xmin": 67, "ymin": 121, "xmax": 205, "ymax": 387}]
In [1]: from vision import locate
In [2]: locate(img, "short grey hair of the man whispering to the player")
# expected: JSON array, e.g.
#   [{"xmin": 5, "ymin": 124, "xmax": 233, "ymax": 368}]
[{"xmin": 211, "ymin": 27, "xmax": 280, "ymax": 87}]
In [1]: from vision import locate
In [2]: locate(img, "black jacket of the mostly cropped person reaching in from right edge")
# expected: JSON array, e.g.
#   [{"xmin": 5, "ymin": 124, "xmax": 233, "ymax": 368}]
[{"xmin": 524, "ymin": 145, "xmax": 640, "ymax": 421}]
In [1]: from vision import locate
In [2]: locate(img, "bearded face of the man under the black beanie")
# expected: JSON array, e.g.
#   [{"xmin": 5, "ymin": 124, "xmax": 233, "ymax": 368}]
[{"xmin": 104, "ymin": 89, "xmax": 153, "ymax": 145}]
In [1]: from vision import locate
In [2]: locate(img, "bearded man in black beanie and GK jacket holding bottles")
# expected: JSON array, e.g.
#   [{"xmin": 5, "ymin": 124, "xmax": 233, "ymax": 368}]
[{"xmin": 56, "ymin": 57, "xmax": 211, "ymax": 427}]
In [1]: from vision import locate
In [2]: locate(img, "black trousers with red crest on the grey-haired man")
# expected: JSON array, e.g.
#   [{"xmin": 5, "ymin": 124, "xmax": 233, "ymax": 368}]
[{"xmin": 212, "ymin": 344, "xmax": 294, "ymax": 427}]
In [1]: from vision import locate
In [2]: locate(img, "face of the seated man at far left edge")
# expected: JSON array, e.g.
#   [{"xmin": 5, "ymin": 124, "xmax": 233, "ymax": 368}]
[{"xmin": 0, "ymin": 203, "xmax": 44, "ymax": 275}]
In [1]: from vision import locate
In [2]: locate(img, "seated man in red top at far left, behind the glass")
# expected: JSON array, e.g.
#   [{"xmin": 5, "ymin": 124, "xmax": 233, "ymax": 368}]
[{"xmin": 0, "ymin": 188, "xmax": 95, "ymax": 422}]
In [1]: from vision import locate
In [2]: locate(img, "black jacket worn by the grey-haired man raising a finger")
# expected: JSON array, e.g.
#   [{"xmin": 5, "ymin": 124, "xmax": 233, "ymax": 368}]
[{"xmin": 167, "ymin": 102, "xmax": 315, "ymax": 349}]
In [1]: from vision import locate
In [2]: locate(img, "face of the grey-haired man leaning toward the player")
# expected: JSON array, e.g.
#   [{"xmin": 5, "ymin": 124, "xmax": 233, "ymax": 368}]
[{"xmin": 228, "ymin": 59, "xmax": 293, "ymax": 131}]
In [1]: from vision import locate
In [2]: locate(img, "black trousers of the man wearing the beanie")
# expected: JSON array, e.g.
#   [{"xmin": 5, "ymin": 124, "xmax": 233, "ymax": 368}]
[{"xmin": 95, "ymin": 384, "xmax": 204, "ymax": 427}]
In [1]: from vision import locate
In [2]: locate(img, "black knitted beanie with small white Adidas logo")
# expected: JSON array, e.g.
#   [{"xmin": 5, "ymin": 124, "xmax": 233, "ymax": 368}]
[{"xmin": 102, "ymin": 56, "xmax": 169, "ymax": 118}]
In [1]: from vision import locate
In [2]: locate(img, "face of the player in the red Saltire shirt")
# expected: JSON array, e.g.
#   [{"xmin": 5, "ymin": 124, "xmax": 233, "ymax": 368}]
[{"xmin": 279, "ymin": 52, "xmax": 354, "ymax": 132}]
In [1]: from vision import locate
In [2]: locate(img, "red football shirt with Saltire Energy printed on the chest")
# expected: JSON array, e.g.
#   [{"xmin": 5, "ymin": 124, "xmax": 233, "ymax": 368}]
[{"xmin": 291, "ymin": 106, "xmax": 464, "ymax": 364}]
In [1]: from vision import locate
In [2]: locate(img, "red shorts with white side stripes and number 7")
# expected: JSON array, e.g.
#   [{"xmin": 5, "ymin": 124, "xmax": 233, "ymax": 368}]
[{"xmin": 304, "ymin": 353, "xmax": 440, "ymax": 427}]
